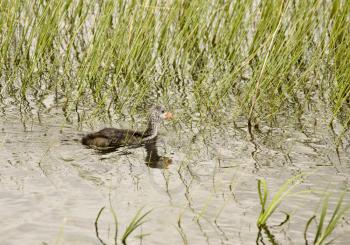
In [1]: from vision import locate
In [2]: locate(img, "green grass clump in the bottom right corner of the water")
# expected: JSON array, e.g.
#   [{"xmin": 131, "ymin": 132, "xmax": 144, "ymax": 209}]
[{"xmin": 304, "ymin": 192, "xmax": 350, "ymax": 245}]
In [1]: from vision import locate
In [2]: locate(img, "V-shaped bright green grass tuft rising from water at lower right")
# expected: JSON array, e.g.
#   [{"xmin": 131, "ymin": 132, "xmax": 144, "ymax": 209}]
[{"xmin": 257, "ymin": 174, "xmax": 306, "ymax": 227}]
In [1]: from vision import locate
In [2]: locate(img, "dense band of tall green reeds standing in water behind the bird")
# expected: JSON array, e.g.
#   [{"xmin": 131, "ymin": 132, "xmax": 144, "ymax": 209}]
[{"xmin": 0, "ymin": 0, "xmax": 350, "ymax": 130}]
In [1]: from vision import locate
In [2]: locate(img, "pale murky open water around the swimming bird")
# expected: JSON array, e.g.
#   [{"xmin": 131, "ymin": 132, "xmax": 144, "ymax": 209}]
[{"xmin": 0, "ymin": 102, "xmax": 350, "ymax": 245}]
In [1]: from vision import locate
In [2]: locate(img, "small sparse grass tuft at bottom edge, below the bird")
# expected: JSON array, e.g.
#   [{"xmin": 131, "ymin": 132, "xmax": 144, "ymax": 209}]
[{"xmin": 95, "ymin": 207, "xmax": 152, "ymax": 245}]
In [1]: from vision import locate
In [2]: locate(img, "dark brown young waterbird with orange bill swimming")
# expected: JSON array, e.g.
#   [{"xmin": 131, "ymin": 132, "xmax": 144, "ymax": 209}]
[{"xmin": 81, "ymin": 105, "xmax": 173, "ymax": 148}]
